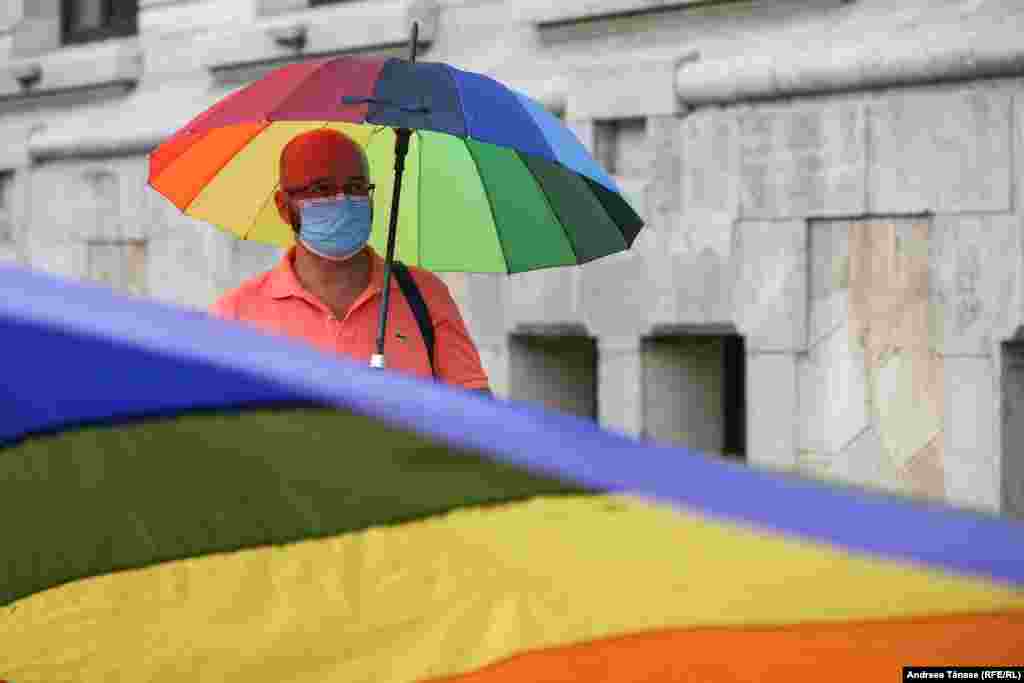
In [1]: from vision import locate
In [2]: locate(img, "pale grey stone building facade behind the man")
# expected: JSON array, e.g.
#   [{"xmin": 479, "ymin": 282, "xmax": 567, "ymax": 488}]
[{"xmin": 0, "ymin": 0, "xmax": 1024, "ymax": 516}]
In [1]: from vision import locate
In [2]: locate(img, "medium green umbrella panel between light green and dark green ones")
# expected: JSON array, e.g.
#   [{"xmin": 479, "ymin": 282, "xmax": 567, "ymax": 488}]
[{"xmin": 467, "ymin": 140, "xmax": 577, "ymax": 273}]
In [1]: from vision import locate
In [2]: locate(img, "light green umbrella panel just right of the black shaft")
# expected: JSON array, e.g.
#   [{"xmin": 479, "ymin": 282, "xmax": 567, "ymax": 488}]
[{"xmin": 419, "ymin": 132, "xmax": 508, "ymax": 272}]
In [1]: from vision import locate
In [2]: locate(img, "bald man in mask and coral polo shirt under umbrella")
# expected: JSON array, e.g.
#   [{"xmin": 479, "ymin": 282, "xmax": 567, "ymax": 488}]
[{"xmin": 211, "ymin": 128, "xmax": 489, "ymax": 392}]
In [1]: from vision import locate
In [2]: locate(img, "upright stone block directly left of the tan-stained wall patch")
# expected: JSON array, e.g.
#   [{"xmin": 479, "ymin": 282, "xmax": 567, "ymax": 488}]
[{"xmin": 733, "ymin": 220, "xmax": 807, "ymax": 351}]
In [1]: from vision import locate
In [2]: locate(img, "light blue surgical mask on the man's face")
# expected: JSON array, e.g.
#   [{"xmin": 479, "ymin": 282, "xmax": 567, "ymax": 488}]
[{"xmin": 296, "ymin": 195, "xmax": 373, "ymax": 261}]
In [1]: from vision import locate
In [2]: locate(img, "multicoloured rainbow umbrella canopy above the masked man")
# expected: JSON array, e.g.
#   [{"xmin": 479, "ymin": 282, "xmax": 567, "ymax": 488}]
[{"xmin": 150, "ymin": 56, "xmax": 643, "ymax": 273}]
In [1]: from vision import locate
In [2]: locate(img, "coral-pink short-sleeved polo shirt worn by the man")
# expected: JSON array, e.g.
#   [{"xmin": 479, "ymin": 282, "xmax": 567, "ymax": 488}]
[{"xmin": 210, "ymin": 247, "xmax": 487, "ymax": 389}]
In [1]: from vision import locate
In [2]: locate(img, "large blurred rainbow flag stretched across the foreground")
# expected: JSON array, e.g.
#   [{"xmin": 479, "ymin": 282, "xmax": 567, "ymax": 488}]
[{"xmin": 0, "ymin": 260, "xmax": 1024, "ymax": 683}]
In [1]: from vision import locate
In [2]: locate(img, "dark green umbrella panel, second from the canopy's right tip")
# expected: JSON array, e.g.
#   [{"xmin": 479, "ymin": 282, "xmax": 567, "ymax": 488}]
[{"xmin": 520, "ymin": 155, "xmax": 627, "ymax": 263}]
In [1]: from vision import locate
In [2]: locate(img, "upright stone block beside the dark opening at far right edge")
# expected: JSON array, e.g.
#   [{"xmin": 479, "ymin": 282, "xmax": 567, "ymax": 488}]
[{"xmin": 942, "ymin": 356, "xmax": 1000, "ymax": 512}]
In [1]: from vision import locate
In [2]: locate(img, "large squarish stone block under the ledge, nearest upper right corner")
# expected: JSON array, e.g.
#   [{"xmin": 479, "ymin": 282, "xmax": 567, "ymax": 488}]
[{"xmin": 867, "ymin": 87, "xmax": 1012, "ymax": 214}]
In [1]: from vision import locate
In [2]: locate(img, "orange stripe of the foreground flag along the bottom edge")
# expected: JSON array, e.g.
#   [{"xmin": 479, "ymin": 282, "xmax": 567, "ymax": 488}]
[{"xmin": 433, "ymin": 611, "xmax": 1024, "ymax": 683}]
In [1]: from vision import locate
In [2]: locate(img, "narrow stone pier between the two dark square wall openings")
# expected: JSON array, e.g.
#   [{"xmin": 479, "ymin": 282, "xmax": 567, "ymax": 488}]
[{"xmin": 597, "ymin": 338, "xmax": 644, "ymax": 436}]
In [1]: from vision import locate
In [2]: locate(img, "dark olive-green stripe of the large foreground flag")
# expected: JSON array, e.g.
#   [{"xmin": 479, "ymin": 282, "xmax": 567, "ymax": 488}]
[{"xmin": 0, "ymin": 408, "xmax": 580, "ymax": 605}]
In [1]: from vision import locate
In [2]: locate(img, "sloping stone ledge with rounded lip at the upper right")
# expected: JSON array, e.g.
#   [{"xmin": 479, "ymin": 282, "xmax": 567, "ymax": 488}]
[{"xmin": 675, "ymin": 0, "xmax": 1024, "ymax": 105}]
